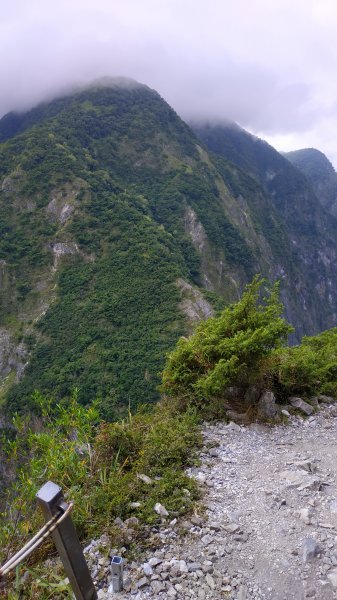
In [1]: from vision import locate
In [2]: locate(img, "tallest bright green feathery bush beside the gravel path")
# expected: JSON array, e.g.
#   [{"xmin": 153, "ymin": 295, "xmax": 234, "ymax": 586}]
[{"xmin": 162, "ymin": 277, "xmax": 292, "ymax": 408}]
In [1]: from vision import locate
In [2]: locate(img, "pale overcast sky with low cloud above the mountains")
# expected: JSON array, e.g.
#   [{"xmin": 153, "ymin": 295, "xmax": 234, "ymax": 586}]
[{"xmin": 0, "ymin": 0, "xmax": 337, "ymax": 167}]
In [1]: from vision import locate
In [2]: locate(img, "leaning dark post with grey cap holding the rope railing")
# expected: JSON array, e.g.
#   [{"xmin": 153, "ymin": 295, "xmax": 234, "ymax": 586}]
[{"xmin": 36, "ymin": 481, "xmax": 97, "ymax": 600}]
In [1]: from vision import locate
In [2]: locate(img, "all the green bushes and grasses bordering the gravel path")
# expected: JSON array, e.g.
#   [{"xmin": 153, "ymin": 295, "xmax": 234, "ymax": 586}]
[{"xmin": 0, "ymin": 277, "xmax": 337, "ymax": 600}]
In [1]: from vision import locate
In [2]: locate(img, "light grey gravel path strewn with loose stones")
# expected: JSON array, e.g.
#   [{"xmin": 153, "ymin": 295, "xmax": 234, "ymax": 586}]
[{"xmin": 88, "ymin": 405, "xmax": 337, "ymax": 600}]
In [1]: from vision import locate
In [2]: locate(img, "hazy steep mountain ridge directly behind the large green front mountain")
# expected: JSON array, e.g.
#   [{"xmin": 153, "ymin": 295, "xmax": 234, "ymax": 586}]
[{"xmin": 192, "ymin": 123, "xmax": 337, "ymax": 334}]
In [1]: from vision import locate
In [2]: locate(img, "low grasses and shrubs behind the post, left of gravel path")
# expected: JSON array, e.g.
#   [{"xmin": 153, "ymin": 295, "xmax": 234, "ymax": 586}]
[{"xmin": 0, "ymin": 394, "xmax": 201, "ymax": 597}]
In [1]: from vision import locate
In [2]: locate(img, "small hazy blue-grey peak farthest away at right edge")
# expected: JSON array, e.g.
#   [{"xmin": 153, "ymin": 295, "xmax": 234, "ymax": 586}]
[{"xmin": 283, "ymin": 148, "xmax": 337, "ymax": 217}]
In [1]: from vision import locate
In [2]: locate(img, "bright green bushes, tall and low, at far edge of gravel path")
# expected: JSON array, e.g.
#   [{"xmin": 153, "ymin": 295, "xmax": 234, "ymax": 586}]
[{"xmin": 162, "ymin": 277, "xmax": 337, "ymax": 417}]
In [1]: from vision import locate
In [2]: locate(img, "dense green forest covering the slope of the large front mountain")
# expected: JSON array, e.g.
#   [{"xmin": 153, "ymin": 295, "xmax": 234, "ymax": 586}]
[{"xmin": 0, "ymin": 86, "xmax": 251, "ymax": 419}]
